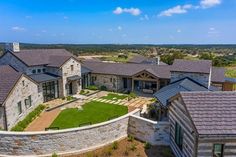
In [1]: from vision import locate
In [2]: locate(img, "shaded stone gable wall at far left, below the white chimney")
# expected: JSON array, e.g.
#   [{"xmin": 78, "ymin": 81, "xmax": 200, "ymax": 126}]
[{"xmin": 0, "ymin": 52, "xmax": 27, "ymax": 72}]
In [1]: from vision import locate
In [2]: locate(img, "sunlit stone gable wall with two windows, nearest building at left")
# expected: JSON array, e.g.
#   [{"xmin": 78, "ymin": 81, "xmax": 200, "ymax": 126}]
[{"xmin": 1, "ymin": 76, "xmax": 43, "ymax": 130}]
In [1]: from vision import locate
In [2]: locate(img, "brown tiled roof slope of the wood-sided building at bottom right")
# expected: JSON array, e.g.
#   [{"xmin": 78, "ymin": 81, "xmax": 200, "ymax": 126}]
[{"xmin": 180, "ymin": 92, "xmax": 236, "ymax": 135}]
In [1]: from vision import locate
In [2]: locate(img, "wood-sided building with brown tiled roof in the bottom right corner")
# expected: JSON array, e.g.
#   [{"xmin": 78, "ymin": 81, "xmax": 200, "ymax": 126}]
[{"xmin": 168, "ymin": 92, "xmax": 236, "ymax": 157}]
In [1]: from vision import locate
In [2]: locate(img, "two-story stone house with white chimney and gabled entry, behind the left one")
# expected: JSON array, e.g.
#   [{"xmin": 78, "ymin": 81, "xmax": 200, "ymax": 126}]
[{"xmin": 0, "ymin": 43, "xmax": 81, "ymax": 102}]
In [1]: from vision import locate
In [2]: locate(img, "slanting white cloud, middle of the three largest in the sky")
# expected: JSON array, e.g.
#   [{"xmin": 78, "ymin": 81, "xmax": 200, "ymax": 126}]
[{"xmin": 159, "ymin": 4, "xmax": 193, "ymax": 16}]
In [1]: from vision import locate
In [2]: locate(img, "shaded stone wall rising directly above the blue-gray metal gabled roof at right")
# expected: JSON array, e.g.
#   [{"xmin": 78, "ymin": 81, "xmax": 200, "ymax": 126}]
[{"xmin": 171, "ymin": 72, "xmax": 211, "ymax": 87}]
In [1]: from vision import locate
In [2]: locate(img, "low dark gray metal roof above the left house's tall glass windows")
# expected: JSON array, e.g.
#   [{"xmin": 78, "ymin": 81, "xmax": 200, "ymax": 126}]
[{"xmin": 29, "ymin": 73, "xmax": 60, "ymax": 83}]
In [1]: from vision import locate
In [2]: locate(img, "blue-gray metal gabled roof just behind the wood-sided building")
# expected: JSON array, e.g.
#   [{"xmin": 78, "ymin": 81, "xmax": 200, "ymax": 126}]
[{"xmin": 154, "ymin": 78, "xmax": 208, "ymax": 107}]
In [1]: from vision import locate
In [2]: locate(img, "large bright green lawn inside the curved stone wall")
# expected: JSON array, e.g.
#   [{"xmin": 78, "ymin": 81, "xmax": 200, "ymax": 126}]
[{"xmin": 50, "ymin": 101, "xmax": 128, "ymax": 129}]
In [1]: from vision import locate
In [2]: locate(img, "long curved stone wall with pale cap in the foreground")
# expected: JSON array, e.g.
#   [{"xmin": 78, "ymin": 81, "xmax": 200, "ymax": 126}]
[{"xmin": 0, "ymin": 109, "xmax": 140, "ymax": 156}]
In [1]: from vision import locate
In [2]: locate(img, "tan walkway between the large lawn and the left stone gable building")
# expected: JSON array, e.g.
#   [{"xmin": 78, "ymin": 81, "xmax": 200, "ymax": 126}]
[{"xmin": 25, "ymin": 108, "xmax": 61, "ymax": 131}]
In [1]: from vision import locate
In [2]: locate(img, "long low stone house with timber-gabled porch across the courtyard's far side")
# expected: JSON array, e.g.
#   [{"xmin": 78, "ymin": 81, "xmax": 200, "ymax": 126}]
[{"xmin": 82, "ymin": 59, "xmax": 233, "ymax": 94}]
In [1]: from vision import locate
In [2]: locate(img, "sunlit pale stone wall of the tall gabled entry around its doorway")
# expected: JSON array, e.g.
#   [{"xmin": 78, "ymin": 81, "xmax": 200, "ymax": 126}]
[{"xmin": 60, "ymin": 58, "xmax": 82, "ymax": 96}]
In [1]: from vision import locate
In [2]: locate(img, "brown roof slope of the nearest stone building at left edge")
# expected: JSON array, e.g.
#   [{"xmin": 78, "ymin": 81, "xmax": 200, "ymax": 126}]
[{"xmin": 0, "ymin": 65, "xmax": 22, "ymax": 104}]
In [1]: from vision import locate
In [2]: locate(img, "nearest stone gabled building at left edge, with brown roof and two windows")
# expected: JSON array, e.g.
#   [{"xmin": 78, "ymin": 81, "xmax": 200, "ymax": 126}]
[{"xmin": 0, "ymin": 65, "xmax": 43, "ymax": 130}]
